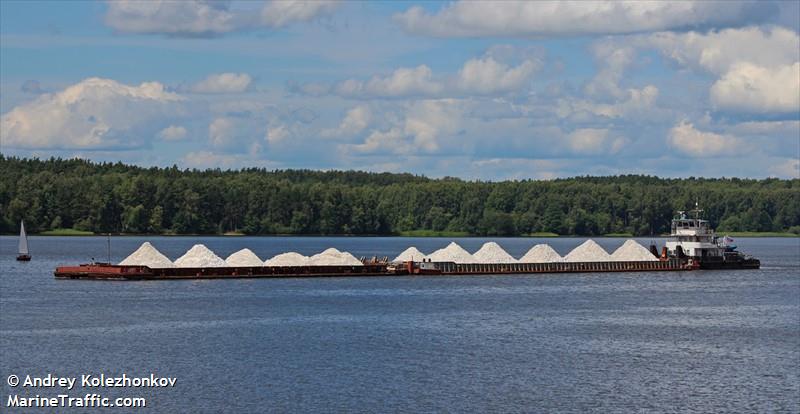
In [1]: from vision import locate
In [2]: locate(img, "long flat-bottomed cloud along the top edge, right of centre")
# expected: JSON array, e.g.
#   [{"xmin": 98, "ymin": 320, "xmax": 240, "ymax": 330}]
[{"xmin": 394, "ymin": 0, "xmax": 768, "ymax": 37}]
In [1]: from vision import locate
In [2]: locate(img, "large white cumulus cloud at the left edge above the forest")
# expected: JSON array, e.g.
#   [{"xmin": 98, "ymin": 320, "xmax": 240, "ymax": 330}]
[{"xmin": 0, "ymin": 78, "xmax": 183, "ymax": 149}]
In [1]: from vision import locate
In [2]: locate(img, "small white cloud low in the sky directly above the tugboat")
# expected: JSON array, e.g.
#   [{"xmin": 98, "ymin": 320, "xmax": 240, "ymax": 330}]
[{"xmin": 667, "ymin": 121, "xmax": 746, "ymax": 157}]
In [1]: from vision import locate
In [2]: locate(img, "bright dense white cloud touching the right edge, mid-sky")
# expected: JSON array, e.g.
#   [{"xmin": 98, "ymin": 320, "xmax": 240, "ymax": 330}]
[{"xmin": 711, "ymin": 62, "xmax": 800, "ymax": 113}]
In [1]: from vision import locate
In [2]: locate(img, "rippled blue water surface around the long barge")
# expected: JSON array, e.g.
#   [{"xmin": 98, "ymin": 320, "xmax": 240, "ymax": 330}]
[{"xmin": 0, "ymin": 237, "xmax": 800, "ymax": 413}]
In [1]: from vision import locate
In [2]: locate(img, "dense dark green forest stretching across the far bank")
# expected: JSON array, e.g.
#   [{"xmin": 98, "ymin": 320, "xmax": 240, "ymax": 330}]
[{"xmin": 0, "ymin": 154, "xmax": 800, "ymax": 236}]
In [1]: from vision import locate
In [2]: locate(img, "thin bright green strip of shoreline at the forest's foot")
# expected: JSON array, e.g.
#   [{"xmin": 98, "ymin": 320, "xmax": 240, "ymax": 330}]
[{"xmin": 7, "ymin": 229, "xmax": 800, "ymax": 238}]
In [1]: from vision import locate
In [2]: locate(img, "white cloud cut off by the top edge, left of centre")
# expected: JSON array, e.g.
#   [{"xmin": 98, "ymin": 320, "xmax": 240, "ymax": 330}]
[{"xmin": 105, "ymin": 0, "xmax": 336, "ymax": 37}]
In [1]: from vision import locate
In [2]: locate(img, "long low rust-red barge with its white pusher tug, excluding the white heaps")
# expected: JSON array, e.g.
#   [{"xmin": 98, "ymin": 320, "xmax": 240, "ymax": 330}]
[{"xmin": 54, "ymin": 208, "xmax": 761, "ymax": 280}]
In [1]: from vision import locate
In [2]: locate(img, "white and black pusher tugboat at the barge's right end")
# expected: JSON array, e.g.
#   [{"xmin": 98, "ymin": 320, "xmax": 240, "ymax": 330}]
[{"xmin": 666, "ymin": 203, "xmax": 761, "ymax": 269}]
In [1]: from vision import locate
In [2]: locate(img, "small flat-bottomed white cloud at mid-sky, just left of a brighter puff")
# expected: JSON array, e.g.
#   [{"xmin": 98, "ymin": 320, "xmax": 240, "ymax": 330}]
[{"xmin": 336, "ymin": 65, "xmax": 443, "ymax": 98}]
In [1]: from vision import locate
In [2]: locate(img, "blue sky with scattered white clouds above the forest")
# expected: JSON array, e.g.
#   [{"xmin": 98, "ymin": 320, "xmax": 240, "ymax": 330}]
[{"xmin": 0, "ymin": 0, "xmax": 800, "ymax": 181}]
